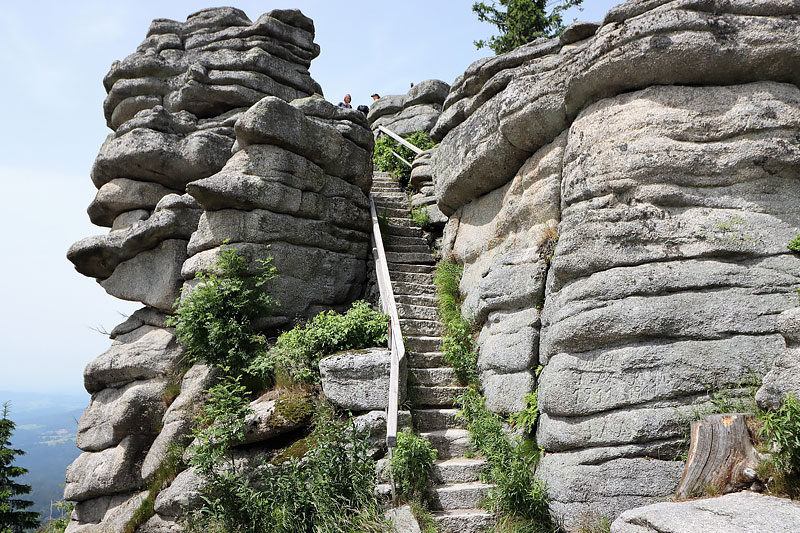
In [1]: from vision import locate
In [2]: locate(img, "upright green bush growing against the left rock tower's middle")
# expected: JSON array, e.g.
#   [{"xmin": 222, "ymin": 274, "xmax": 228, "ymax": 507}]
[{"xmin": 167, "ymin": 245, "xmax": 276, "ymax": 371}]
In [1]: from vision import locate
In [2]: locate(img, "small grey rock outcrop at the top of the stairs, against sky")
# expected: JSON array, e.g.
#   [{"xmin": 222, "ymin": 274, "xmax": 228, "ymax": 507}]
[{"xmin": 367, "ymin": 80, "xmax": 450, "ymax": 135}]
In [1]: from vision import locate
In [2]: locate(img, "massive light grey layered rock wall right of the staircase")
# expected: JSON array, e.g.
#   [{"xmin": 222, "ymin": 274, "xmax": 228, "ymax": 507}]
[{"xmin": 431, "ymin": 0, "xmax": 800, "ymax": 528}]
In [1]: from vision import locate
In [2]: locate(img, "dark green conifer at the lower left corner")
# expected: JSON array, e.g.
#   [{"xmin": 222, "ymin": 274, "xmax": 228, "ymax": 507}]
[{"xmin": 0, "ymin": 402, "xmax": 39, "ymax": 533}]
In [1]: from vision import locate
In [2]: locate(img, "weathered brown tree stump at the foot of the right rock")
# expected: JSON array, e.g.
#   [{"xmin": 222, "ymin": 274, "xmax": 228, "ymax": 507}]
[{"xmin": 677, "ymin": 413, "xmax": 760, "ymax": 498}]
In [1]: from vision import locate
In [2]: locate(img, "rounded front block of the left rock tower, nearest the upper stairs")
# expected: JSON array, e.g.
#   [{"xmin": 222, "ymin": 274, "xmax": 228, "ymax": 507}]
[{"xmin": 182, "ymin": 94, "xmax": 373, "ymax": 327}]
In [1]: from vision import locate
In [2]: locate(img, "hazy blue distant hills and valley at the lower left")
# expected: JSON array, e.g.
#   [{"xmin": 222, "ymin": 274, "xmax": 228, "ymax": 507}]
[{"xmin": 0, "ymin": 391, "xmax": 89, "ymax": 518}]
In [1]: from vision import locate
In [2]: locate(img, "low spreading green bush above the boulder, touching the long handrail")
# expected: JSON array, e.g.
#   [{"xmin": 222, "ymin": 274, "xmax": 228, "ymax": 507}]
[{"xmin": 249, "ymin": 301, "xmax": 388, "ymax": 383}]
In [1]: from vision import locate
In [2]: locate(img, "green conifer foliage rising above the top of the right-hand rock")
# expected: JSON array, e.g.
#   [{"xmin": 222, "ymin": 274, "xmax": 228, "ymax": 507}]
[{"xmin": 472, "ymin": 0, "xmax": 583, "ymax": 55}]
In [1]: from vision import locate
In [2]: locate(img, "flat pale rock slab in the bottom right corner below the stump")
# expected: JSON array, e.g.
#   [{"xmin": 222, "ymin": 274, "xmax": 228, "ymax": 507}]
[{"xmin": 611, "ymin": 491, "xmax": 800, "ymax": 533}]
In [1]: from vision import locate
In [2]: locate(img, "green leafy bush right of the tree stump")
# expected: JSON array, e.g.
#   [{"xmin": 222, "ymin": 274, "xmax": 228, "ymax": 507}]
[{"xmin": 759, "ymin": 392, "xmax": 800, "ymax": 497}]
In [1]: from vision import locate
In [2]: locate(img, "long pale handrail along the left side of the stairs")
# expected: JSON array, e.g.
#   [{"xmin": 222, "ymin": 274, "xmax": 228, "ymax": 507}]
[{"xmin": 369, "ymin": 194, "xmax": 406, "ymax": 448}]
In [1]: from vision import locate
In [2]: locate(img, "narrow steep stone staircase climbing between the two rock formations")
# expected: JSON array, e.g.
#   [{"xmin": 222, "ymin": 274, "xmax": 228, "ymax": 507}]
[{"xmin": 372, "ymin": 172, "xmax": 491, "ymax": 533}]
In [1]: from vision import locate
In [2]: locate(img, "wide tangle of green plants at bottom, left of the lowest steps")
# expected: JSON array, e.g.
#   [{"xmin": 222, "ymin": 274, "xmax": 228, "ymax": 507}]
[{"xmin": 190, "ymin": 410, "xmax": 386, "ymax": 533}]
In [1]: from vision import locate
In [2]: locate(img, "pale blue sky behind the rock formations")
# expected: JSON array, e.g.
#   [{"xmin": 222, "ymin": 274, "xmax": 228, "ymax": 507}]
[{"xmin": 0, "ymin": 0, "xmax": 619, "ymax": 394}]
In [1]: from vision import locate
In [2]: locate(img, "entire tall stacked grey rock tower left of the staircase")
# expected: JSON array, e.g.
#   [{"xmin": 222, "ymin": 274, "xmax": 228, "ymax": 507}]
[{"xmin": 64, "ymin": 8, "xmax": 373, "ymax": 532}]
